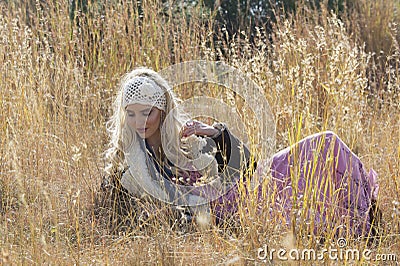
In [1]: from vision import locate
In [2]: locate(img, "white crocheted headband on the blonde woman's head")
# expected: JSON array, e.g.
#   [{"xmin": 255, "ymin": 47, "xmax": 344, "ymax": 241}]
[{"xmin": 123, "ymin": 76, "xmax": 167, "ymax": 111}]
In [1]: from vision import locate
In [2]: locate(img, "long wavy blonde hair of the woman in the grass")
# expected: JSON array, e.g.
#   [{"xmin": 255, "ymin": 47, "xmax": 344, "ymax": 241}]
[{"xmin": 105, "ymin": 68, "xmax": 189, "ymax": 175}]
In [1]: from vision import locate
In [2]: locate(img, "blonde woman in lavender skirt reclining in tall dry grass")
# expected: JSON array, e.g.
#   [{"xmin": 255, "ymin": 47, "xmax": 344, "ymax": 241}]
[{"xmin": 98, "ymin": 68, "xmax": 378, "ymax": 236}]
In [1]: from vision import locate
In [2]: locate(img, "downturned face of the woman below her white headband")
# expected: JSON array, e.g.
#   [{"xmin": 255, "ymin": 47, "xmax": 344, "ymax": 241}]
[{"xmin": 126, "ymin": 103, "xmax": 162, "ymax": 139}]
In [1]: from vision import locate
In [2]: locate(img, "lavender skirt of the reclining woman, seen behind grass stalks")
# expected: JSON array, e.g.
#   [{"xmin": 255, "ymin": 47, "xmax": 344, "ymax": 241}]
[{"xmin": 212, "ymin": 131, "xmax": 379, "ymax": 236}]
